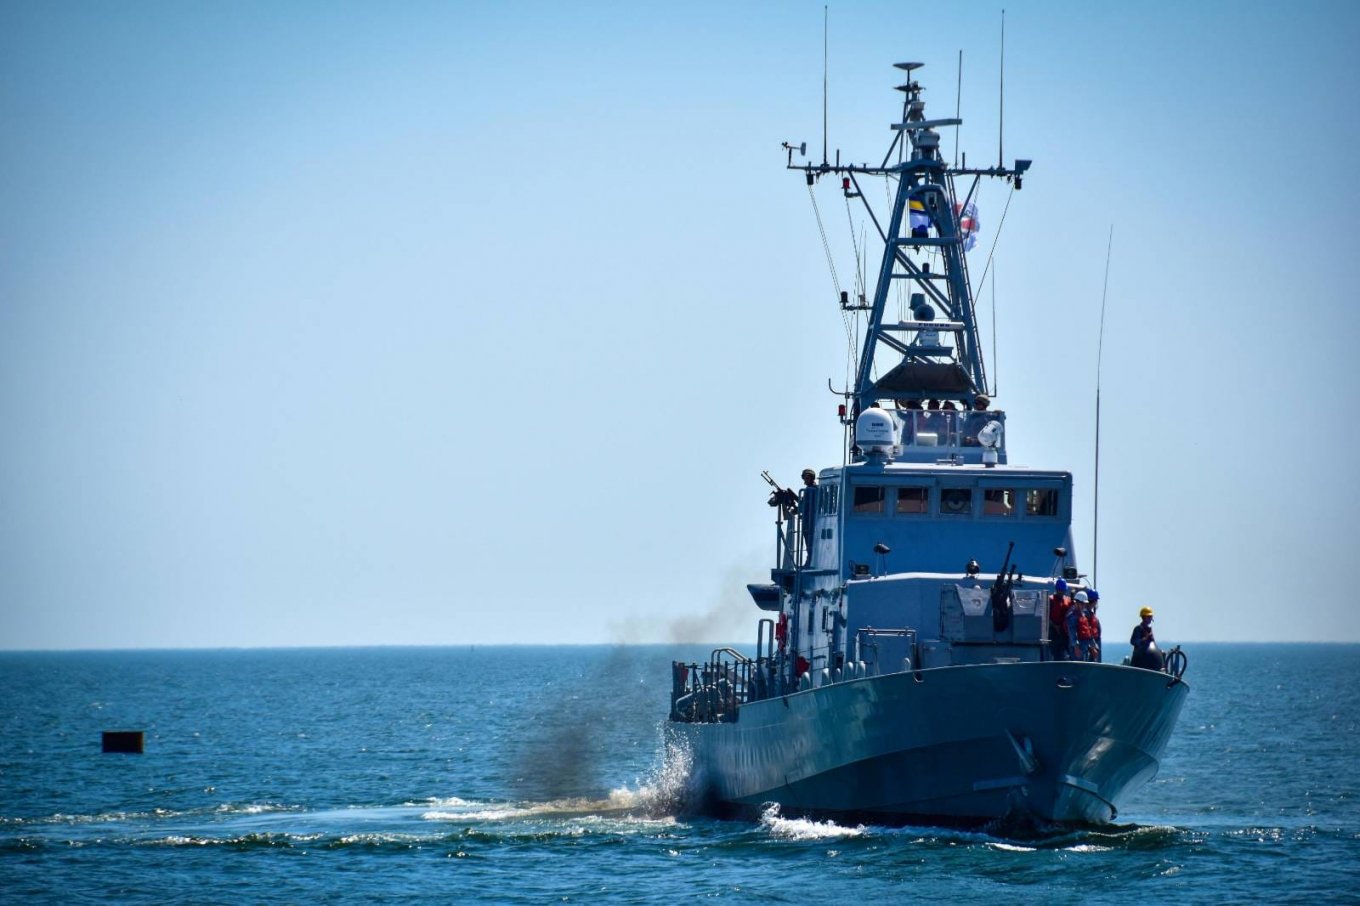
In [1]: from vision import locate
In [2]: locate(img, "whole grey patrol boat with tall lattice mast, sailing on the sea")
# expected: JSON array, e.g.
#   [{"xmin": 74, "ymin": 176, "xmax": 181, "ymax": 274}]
[{"xmin": 666, "ymin": 63, "xmax": 1189, "ymax": 826}]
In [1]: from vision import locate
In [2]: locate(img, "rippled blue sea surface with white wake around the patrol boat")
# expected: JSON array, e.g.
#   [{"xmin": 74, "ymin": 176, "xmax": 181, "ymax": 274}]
[{"xmin": 0, "ymin": 643, "xmax": 1360, "ymax": 903}]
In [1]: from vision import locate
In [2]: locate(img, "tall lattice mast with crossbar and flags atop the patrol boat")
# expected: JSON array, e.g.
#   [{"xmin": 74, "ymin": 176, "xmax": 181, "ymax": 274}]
[{"xmin": 785, "ymin": 63, "xmax": 1030, "ymax": 419}]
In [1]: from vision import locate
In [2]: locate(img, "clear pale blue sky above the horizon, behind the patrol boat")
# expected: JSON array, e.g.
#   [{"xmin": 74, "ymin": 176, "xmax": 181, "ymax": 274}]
[{"xmin": 0, "ymin": 1, "xmax": 1360, "ymax": 649}]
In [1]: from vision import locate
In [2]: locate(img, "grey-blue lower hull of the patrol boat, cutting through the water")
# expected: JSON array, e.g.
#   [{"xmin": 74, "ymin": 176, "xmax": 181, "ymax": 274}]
[{"xmin": 668, "ymin": 661, "xmax": 1189, "ymax": 824}]
